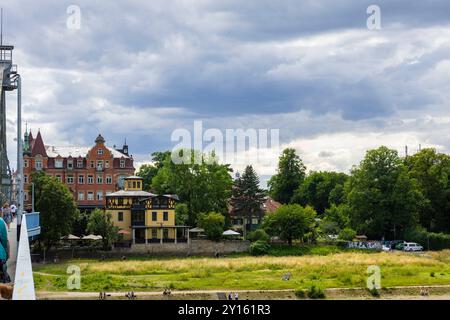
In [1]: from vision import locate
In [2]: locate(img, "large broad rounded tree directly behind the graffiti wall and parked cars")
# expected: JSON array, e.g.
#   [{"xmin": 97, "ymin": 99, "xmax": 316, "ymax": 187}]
[{"xmin": 348, "ymin": 147, "xmax": 423, "ymax": 238}]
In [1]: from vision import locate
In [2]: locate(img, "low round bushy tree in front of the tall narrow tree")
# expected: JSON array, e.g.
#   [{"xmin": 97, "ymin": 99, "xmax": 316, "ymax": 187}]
[{"xmin": 263, "ymin": 204, "xmax": 317, "ymax": 245}]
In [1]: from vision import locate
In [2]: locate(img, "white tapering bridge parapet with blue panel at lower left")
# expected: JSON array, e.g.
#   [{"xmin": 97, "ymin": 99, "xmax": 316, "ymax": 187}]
[{"xmin": 13, "ymin": 212, "xmax": 40, "ymax": 300}]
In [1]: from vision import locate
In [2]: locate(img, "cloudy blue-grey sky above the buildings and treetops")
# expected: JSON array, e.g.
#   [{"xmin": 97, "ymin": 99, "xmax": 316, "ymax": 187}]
[{"xmin": 1, "ymin": 0, "xmax": 450, "ymax": 185}]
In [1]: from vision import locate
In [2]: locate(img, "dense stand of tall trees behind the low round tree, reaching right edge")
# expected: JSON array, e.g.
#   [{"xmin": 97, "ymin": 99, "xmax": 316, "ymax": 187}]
[{"xmin": 269, "ymin": 146, "xmax": 450, "ymax": 239}]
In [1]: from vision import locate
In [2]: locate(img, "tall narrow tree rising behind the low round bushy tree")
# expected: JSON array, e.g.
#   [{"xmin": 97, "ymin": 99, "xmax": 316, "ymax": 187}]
[{"xmin": 268, "ymin": 149, "xmax": 306, "ymax": 204}]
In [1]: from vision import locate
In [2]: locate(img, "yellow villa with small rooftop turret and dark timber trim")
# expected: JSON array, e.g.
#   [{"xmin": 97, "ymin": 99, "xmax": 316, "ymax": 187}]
[{"xmin": 106, "ymin": 176, "xmax": 189, "ymax": 244}]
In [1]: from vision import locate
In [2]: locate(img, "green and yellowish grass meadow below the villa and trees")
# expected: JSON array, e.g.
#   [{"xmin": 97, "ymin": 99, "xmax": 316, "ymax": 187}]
[{"xmin": 34, "ymin": 250, "xmax": 450, "ymax": 292}]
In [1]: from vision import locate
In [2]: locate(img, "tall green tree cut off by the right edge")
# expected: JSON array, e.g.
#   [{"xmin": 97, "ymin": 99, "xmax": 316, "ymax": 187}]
[{"xmin": 405, "ymin": 149, "xmax": 450, "ymax": 233}]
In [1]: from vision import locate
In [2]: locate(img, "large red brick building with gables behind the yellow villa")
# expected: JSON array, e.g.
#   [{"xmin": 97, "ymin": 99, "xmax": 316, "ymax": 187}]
[{"xmin": 24, "ymin": 131, "xmax": 135, "ymax": 211}]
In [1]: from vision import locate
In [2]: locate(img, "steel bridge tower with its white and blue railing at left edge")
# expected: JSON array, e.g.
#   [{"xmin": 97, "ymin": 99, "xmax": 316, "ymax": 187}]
[{"xmin": 0, "ymin": 40, "xmax": 40, "ymax": 300}]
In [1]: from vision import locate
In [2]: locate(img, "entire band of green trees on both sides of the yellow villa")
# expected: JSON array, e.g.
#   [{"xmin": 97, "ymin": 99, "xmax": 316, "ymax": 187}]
[{"xmin": 29, "ymin": 147, "xmax": 450, "ymax": 247}]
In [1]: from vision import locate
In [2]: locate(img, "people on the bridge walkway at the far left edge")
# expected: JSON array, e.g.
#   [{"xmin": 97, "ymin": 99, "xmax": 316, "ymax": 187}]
[{"xmin": 0, "ymin": 203, "xmax": 17, "ymax": 283}]
